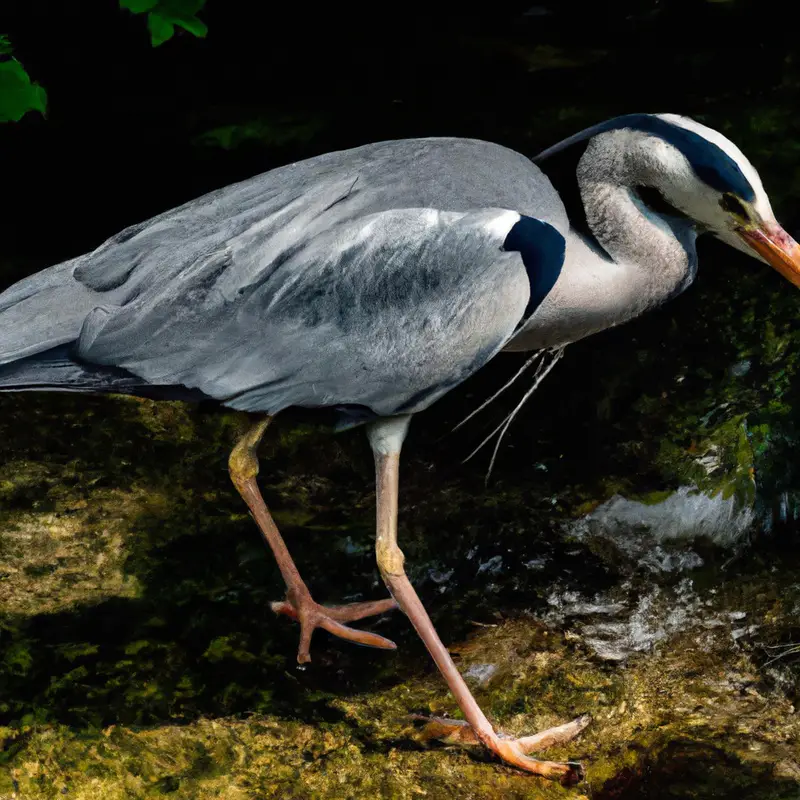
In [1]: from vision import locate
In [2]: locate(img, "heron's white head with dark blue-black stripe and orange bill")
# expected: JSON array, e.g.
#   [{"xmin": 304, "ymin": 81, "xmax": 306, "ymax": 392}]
[{"xmin": 645, "ymin": 114, "xmax": 800, "ymax": 286}]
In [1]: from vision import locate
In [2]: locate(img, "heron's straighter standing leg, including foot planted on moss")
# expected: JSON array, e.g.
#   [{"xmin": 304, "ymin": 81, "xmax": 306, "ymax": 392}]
[{"xmin": 368, "ymin": 418, "xmax": 589, "ymax": 784}]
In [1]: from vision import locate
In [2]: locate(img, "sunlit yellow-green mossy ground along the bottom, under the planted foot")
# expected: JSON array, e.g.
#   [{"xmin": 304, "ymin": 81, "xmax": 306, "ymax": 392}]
[{"xmin": 0, "ymin": 608, "xmax": 800, "ymax": 799}]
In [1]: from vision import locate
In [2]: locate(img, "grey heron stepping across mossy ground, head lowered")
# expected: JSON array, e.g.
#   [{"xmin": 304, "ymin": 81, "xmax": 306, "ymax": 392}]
[{"xmin": 0, "ymin": 114, "xmax": 800, "ymax": 782}]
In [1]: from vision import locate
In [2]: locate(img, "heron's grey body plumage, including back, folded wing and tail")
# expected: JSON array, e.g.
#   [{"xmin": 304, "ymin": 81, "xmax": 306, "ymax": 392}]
[{"xmin": 0, "ymin": 139, "xmax": 567, "ymax": 424}]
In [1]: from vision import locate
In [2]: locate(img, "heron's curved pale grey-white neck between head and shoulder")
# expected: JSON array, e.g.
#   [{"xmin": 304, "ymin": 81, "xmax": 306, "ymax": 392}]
[{"xmin": 506, "ymin": 131, "xmax": 696, "ymax": 350}]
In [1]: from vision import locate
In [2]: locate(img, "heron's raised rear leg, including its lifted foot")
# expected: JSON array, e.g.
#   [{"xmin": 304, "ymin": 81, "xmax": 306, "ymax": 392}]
[{"xmin": 228, "ymin": 417, "xmax": 397, "ymax": 664}]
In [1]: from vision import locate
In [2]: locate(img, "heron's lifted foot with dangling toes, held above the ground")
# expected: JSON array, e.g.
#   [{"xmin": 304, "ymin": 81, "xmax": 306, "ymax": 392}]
[{"xmin": 271, "ymin": 592, "xmax": 397, "ymax": 664}]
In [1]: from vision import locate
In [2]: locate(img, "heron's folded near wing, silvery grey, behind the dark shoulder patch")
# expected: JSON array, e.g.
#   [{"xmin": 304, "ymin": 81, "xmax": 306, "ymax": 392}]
[{"xmin": 76, "ymin": 208, "xmax": 552, "ymax": 422}]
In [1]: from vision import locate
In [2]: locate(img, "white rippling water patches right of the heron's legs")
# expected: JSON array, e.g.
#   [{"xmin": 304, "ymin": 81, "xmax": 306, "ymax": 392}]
[{"xmin": 544, "ymin": 487, "xmax": 754, "ymax": 662}]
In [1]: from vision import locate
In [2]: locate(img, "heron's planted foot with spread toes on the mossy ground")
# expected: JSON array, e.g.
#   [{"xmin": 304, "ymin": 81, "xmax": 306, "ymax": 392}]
[{"xmin": 415, "ymin": 714, "xmax": 592, "ymax": 786}]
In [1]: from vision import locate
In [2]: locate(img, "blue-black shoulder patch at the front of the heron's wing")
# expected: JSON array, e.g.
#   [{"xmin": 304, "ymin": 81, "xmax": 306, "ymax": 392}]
[{"xmin": 503, "ymin": 216, "xmax": 567, "ymax": 319}]
